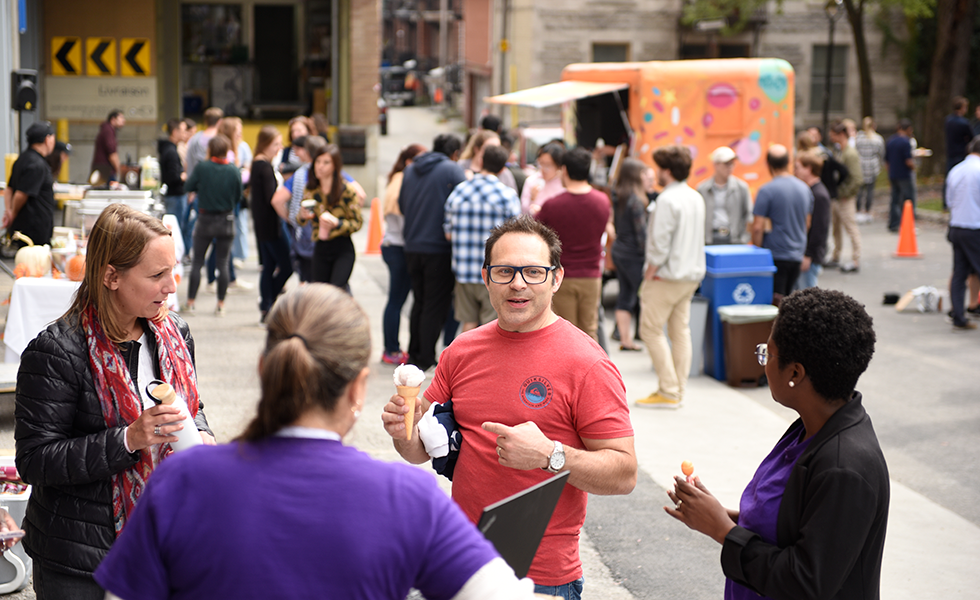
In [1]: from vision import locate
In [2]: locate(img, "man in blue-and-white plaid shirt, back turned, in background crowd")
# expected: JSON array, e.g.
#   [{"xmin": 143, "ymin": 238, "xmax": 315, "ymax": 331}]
[{"xmin": 443, "ymin": 146, "xmax": 521, "ymax": 331}]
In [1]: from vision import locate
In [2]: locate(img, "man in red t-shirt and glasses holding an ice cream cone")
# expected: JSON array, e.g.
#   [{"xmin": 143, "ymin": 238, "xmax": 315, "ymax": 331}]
[{"xmin": 382, "ymin": 216, "xmax": 636, "ymax": 598}]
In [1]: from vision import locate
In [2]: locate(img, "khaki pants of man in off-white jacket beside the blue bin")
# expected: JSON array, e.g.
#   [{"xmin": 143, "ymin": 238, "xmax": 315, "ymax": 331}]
[{"xmin": 640, "ymin": 279, "xmax": 699, "ymax": 400}]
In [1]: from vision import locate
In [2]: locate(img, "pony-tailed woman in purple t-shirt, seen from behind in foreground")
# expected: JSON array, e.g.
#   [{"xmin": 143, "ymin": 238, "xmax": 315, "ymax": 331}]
[{"xmin": 95, "ymin": 283, "xmax": 534, "ymax": 600}]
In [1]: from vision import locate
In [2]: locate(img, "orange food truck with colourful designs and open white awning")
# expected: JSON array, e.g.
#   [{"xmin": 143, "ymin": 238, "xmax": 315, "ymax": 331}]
[{"xmin": 487, "ymin": 58, "xmax": 795, "ymax": 195}]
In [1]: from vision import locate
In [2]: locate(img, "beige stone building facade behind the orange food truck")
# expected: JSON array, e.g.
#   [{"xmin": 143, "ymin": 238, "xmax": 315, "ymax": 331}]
[{"xmin": 486, "ymin": 0, "xmax": 908, "ymax": 128}]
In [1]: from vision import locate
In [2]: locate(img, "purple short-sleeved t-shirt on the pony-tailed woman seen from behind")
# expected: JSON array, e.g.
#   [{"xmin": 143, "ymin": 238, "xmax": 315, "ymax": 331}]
[{"xmin": 95, "ymin": 437, "xmax": 497, "ymax": 600}]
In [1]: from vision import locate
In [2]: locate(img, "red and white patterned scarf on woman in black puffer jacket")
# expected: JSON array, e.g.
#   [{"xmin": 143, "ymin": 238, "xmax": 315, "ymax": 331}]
[{"xmin": 80, "ymin": 307, "xmax": 200, "ymax": 537}]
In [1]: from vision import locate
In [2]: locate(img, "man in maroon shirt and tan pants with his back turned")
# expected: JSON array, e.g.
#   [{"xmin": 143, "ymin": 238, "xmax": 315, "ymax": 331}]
[{"xmin": 535, "ymin": 148, "xmax": 611, "ymax": 341}]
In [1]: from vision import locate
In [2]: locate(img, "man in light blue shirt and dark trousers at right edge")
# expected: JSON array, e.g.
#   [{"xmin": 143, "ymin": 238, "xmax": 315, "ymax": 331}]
[{"xmin": 946, "ymin": 135, "xmax": 980, "ymax": 329}]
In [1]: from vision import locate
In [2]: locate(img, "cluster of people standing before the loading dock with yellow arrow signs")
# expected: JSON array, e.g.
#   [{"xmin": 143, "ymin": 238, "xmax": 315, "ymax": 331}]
[{"xmin": 153, "ymin": 107, "xmax": 365, "ymax": 322}]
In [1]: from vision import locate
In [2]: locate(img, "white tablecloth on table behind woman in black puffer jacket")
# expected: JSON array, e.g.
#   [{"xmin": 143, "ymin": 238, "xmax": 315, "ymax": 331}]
[{"xmin": 3, "ymin": 277, "xmax": 79, "ymax": 363}]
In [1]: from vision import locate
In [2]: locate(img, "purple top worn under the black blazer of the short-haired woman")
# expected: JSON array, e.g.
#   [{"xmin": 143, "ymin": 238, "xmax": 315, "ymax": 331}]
[{"xmin": 725, "ymin": 425, "xmax": 813, "ymax": 600}]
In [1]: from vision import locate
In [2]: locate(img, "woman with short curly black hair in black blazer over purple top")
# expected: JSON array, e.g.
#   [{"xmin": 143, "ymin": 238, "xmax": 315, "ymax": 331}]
[{"xmin": 665, "ymin": 288, "xmax": 889, "ymax": 600}]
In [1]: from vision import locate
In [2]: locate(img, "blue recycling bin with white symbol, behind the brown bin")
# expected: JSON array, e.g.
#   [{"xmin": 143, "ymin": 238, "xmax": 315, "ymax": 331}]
[{"xmin": 701, "ymin": 245, "xmax": 776, "ymax": 381}]
